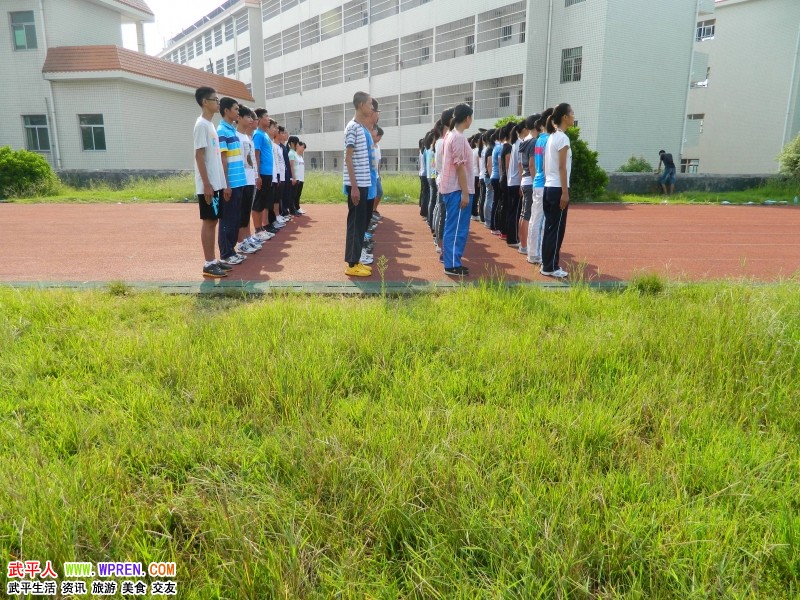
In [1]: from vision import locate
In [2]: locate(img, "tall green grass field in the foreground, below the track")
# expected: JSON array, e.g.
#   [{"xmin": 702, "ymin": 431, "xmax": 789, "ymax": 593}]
[{"xmin": 0, "ymin": 284, "xmax": 800, "ymax": 600}]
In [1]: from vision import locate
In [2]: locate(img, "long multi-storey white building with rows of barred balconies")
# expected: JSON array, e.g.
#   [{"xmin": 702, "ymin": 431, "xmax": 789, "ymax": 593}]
[{"xmin": 162, "ymin": 0, "xmax": 713, "ymax": 169}]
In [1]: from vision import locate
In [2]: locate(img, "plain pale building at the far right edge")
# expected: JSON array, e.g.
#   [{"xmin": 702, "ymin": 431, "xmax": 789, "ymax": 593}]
[{"xmin": 681, "ymin": 0, "xmax": 800, "ymax": 174}]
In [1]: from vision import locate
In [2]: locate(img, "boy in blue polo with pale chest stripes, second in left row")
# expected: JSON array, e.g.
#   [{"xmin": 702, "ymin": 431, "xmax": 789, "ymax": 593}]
[{"xmin": 217, "ymin": 97, "xmax": 247, "ymax": 265}]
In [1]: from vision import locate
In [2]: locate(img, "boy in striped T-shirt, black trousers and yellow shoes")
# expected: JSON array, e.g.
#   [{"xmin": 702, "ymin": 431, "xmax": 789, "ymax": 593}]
[{"xmin": 343, "ymin": 92, "xmax": 372, "ymax": 277}]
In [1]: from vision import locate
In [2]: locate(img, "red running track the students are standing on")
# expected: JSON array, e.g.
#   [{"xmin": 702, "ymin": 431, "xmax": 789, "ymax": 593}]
[{"xmin": 0, "ymin": 204, "xmax": 800, "ymax": 283}]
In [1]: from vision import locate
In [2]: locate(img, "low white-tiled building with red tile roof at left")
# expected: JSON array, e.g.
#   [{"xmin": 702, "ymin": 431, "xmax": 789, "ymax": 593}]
[{"xmin": 0, "ymin": 0, "xmax": 252, "ymax": 170}]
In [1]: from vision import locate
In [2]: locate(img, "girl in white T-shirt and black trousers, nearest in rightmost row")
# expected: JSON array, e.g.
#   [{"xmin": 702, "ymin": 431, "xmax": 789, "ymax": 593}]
[{"xmin": 539, "ymin": 102, "xmax": 575, "ymax": 279}]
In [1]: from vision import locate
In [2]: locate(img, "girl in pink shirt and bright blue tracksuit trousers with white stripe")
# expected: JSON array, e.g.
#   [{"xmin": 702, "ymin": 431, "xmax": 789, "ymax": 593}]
[{"xmin": 441, "ymin": 104, "xmax": 475, "ymax": 277}]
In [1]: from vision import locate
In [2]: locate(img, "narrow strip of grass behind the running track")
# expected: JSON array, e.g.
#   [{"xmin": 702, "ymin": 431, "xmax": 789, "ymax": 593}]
[{"xmin": 8, "ymin": 171, "xmax": 800, "ymax": 204}]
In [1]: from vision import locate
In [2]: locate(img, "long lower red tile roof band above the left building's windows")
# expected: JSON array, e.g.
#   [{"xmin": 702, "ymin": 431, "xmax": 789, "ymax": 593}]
[{"xmin": 42, "ymin": 46, "xmax": 253, "ymax": 102}]
